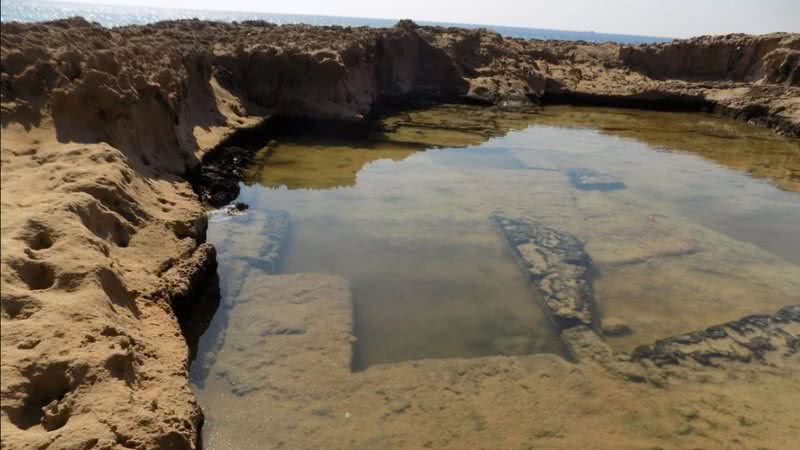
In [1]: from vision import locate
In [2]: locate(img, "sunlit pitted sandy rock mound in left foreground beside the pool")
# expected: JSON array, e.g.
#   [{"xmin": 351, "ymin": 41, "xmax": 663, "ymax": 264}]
[{"xmin": 2, "ymin": 124, "xmax": 214, "ymax": 448}]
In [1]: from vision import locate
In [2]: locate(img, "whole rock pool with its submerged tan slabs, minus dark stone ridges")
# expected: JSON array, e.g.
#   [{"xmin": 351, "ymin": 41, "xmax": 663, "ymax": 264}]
[{"xmin": 195, "ymin": 106, "xmax": 800, "ymax": 448}]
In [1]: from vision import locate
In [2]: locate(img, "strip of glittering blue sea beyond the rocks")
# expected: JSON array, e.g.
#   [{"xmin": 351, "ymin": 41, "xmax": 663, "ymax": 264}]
[{"xmin": 0, "ymin": 0, "xmax": 672, "ymax": 44}]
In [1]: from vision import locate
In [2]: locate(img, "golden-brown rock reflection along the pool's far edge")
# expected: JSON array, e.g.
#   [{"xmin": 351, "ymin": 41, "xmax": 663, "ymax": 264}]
[{"xmin": 246, "ymin": 105, "xmax": 800, "ymax": 192}]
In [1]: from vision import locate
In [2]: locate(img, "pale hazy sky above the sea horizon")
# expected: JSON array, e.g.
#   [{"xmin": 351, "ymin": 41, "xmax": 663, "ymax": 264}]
[{"xmin": 57, "ymin": 0, "xmax": 800, "ymax": 37}]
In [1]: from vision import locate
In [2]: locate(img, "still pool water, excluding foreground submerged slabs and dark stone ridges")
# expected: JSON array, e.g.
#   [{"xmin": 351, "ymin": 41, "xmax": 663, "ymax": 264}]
[{"xmin": 193, "ymin": 106, "xmax": 800, "ymax": 447}]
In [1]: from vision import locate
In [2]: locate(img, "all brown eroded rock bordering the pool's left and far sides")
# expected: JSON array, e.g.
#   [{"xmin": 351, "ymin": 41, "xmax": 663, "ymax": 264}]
[{"xmin": 0, "ymin": 18, "xmax": 800, "ymax": 448}]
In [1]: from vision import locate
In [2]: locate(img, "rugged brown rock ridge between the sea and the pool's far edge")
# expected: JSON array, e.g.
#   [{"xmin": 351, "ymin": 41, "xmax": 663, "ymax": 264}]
[{"xmin": 2, "ymin": 18, "xmax": 800, "ymax": 139}]
